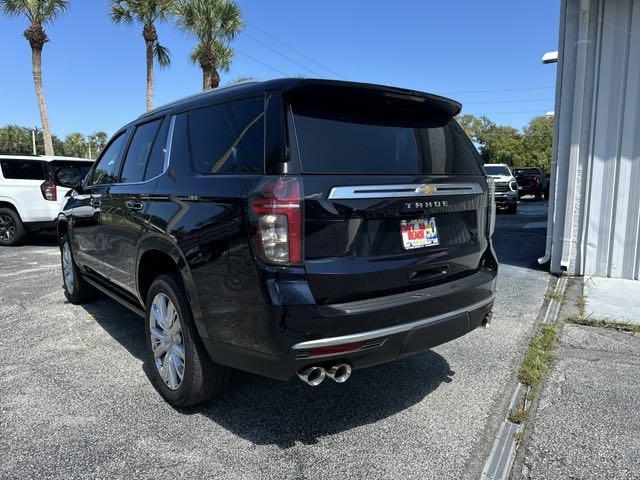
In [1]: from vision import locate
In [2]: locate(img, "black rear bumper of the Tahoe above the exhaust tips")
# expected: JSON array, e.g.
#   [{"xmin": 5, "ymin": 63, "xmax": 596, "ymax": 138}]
[{"xmin": 203, "ymin": 270, "xmax": 496, "ymax": 380}]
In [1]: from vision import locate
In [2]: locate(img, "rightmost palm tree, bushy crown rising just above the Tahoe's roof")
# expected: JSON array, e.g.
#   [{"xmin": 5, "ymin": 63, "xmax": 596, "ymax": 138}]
[{"xmin": 176, "ymin": 0, "xmax": 243, "ymax": 90}]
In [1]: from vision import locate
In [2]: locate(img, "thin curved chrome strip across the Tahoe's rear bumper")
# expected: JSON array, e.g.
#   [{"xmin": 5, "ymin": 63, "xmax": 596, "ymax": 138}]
[{"xmin": 292, "ymin": 295, "xmax": 495, "ymax": 350}]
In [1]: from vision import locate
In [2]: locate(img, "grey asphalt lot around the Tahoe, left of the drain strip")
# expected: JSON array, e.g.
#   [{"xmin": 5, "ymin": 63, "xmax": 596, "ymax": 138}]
[{"xmin": 0, "ymin": 201, "xmax": 548, "ymax": 479}]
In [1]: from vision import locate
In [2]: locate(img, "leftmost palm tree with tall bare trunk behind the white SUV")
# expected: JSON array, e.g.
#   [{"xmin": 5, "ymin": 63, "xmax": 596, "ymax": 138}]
[{"xmin": 0, "ymin": 0, "xmax": 69, "ymax": 155}]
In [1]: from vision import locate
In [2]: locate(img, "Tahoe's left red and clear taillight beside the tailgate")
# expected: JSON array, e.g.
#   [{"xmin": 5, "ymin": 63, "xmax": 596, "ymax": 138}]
[{"xmin": 249, "ymin": 176, "xmax": 302, "ymax": 265}]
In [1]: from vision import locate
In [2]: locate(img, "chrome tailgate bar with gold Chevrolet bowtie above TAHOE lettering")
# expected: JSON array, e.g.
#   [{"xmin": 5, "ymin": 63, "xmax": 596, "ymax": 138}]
[{"xmin": 329, "ymin": 183, "xmax": 482, "ymax": 200}]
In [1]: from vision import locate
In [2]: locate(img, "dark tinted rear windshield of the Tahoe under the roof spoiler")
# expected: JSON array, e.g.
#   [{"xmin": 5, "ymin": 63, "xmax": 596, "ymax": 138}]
[{"xmin": 290, "ymin": 105, "xmax": 482, "ymax": 175}]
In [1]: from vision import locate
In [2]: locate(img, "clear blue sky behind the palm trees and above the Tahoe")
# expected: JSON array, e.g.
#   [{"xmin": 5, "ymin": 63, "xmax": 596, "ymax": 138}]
[{"xmin": 0, "ymin": 0, "xmax": 560, "ymax": 136}]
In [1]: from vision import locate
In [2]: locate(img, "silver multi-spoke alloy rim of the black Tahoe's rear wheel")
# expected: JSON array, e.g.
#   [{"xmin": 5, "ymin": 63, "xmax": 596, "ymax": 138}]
[{"xmin": 149, "ymin": 293, "xmax": 185, "ymax": 390}]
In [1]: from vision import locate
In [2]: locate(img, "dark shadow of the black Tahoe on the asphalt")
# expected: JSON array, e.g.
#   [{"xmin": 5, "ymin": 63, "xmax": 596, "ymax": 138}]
[{"xmin": 83, "ymin": 296, "xmax": 455, "ymax": 449}]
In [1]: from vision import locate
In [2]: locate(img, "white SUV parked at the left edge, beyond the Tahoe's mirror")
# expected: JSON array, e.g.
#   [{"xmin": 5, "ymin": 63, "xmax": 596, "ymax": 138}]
[{"xmin": 0, "ymin": 155, "xmax": 93, "ymax": 246}]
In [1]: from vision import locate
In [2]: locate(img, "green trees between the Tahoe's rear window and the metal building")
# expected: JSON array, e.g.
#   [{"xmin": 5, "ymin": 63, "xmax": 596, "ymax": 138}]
[{"xmin": 458, "ymin": 114, "xmax": 553, "ymax": 172}]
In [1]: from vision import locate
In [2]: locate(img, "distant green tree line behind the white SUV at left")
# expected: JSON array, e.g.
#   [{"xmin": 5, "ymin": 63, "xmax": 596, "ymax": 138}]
[{"xmin": 0, "ymin": 125, "xmax": 109, "ymax": 158}]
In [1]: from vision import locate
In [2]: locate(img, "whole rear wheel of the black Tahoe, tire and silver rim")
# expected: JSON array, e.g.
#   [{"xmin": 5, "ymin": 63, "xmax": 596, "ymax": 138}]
[{"xmin": 145, "ymin": 273, "xmax": 230, "ymax": 407}]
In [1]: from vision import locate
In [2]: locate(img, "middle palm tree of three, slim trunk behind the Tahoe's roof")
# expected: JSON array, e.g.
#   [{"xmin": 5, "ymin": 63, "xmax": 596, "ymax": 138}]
[{"xmin": 110, "ymin": 0, "xmax": 174, "ymax": 111}]
